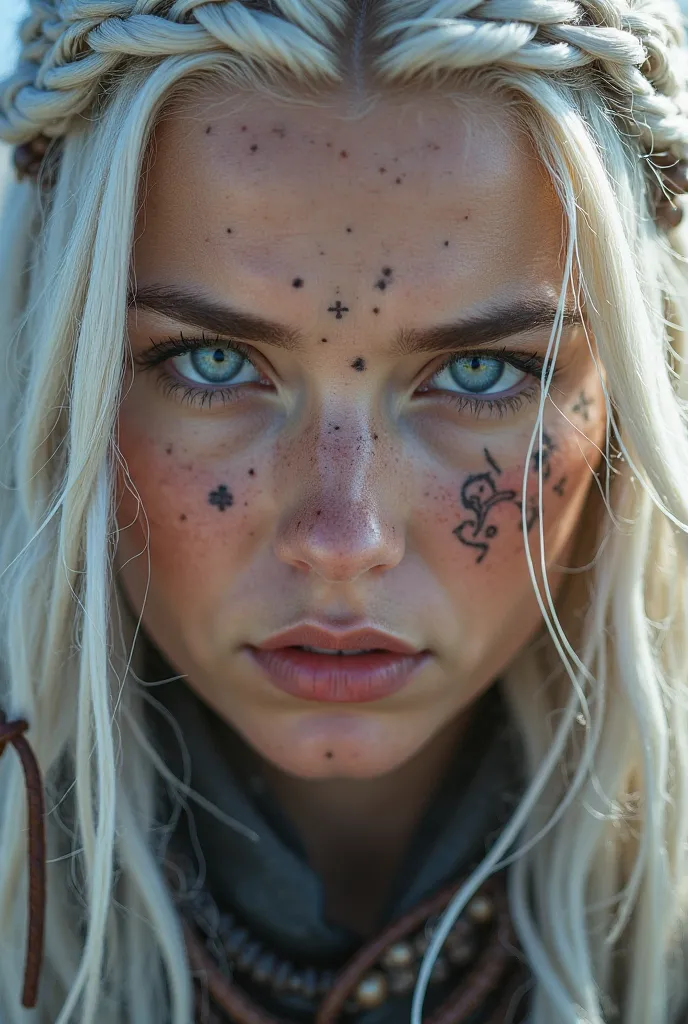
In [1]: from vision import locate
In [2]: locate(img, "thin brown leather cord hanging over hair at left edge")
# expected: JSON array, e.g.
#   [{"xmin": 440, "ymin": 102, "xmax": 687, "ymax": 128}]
[{"xmin": 0, "ymin": 709, "xmax": 46, "ymax": 1009}]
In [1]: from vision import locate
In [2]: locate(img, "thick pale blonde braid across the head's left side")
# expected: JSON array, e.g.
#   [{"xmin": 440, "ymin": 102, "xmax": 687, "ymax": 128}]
[{"xmin": 0, "ymin": 0, "xmax": 344, "ymax": 144}]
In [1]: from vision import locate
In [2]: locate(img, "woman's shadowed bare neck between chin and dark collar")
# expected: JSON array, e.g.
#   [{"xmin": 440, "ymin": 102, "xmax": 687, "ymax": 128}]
[{"xmin": 254, "ymin": 711, "xmax": 472, "ymax": 936}]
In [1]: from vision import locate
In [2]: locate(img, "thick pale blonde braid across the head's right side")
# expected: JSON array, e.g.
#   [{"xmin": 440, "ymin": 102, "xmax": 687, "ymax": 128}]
[{"xmin": 378, "ymin": 0, "xmax": 688, "ymax": 159}]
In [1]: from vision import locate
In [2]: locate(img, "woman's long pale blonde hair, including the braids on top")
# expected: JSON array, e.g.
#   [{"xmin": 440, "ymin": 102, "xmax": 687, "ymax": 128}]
[{"xmin": 0, "ymin": 0, "xmax": 688, "ymax": 1024}]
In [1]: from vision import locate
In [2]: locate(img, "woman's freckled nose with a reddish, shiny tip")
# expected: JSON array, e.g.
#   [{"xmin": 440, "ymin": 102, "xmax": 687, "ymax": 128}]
[{"xmin": 274, "ymin": 428, "xmax": 405, "ymax": 583}]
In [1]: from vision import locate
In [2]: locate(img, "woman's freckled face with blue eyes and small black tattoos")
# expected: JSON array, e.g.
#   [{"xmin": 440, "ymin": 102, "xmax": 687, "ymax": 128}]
[{"xmin": 118, "ymin": 91, "xmax": 604, "ymax": 778}]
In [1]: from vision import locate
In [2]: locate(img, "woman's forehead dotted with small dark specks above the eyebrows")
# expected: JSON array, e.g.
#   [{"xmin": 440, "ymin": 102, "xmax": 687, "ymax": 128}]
[{"xmin": 136, "ymin": 86, "xmax": 562, "ymax": 308}]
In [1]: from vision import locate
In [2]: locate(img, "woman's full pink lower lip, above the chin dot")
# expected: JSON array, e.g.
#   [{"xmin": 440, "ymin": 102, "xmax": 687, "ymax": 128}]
[{"xmin": 248, "ymin": 647, "xmax": 430, "ymax": 703}]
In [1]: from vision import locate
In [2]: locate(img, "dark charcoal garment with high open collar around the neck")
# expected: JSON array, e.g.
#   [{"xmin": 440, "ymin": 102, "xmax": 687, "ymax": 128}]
[{"xmin": 147, "ymin": 666, "xmax": 522, "ymax": 1024}]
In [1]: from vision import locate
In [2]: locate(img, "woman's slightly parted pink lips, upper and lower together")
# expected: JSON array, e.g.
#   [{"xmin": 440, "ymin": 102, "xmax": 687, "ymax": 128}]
[{"xmin": 247, "ymin": 626, "xmax": 430, "ymax": 703}]
